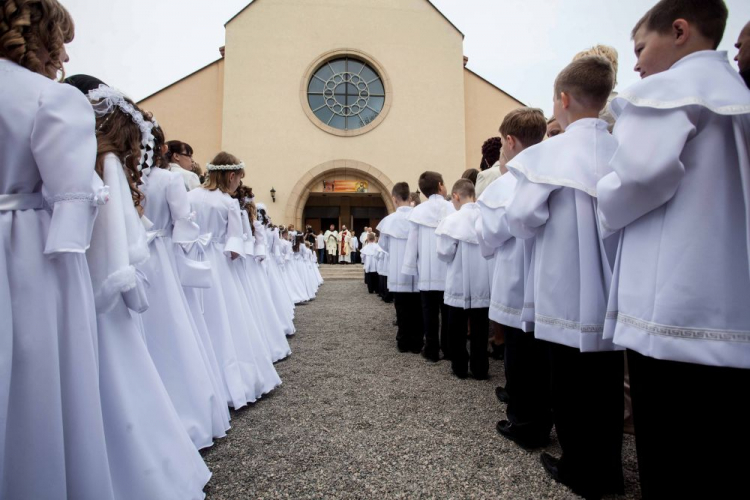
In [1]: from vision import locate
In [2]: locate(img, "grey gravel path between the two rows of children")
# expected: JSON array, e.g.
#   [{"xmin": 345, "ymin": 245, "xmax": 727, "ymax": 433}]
[{"xmin": 203, "ymin": 281, "xmax": 638, "ymax": 500}]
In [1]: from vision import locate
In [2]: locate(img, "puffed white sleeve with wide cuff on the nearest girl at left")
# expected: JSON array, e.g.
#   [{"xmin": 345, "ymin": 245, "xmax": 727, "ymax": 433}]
[{"xmin": 30, "ymin": 85, "xmax": 97, "ymax": 254}]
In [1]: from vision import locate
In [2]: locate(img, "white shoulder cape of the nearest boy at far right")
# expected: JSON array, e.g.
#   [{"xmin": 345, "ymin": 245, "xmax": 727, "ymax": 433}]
[{"xmin": 612, "ymin": 50, "xmax": 750, "ymax": 119}]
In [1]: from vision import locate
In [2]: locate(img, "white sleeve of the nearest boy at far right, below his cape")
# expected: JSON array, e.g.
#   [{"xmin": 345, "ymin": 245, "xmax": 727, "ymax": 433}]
[{"xmin": 596, "ymin": 106, "xmax": 700, "ymax": 237}]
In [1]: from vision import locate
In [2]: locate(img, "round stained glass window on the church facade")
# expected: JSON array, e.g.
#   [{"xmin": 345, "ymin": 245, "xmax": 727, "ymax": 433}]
[{"xmin": 307, "ymin": 57, "xmax": 385, "ymax": 130}]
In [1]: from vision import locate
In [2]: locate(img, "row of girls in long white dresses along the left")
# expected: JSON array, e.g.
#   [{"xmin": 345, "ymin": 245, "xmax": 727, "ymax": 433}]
[{"xmin": 0, "ymin": 0, "xmax": 321, "ymax": 500}]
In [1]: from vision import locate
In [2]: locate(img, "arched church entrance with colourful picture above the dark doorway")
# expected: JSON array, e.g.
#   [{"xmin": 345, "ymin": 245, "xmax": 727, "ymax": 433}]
[{"xmin": 286, "ymin": 160, "xmax": 394, "ymax": 238}]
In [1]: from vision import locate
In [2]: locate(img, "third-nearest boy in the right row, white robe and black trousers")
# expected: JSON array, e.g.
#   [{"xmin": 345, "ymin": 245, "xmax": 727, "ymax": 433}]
[{"xmin": 476, "ymin": 108, "xmax": 552, "ymax": 449}]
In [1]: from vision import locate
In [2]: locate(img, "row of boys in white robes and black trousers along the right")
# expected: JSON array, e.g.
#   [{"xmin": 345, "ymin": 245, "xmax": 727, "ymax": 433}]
[{"xmin": 363, "ymin": 0, "xmax": 750, "ymax": 499}]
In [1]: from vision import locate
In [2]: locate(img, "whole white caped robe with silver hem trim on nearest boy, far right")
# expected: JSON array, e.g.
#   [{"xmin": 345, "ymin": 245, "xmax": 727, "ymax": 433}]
[{"xmin": 597, "ymin": 51, "xmax": 750, "ymax": 368}]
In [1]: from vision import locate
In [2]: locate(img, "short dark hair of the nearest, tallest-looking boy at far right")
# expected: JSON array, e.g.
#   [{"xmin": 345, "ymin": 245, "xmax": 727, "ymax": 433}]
[{"xmin": 630, "ymin": 0, "xmax": 729, "ymax": 50}]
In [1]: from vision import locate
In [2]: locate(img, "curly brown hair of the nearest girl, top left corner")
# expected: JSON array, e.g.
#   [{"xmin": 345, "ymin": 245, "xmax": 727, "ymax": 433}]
[{"xmin": 0, "ymin": 0, "xmax": 75, "ymax": 79}]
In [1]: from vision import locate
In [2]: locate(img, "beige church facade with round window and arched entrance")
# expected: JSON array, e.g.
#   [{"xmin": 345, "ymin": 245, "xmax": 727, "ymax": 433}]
[{"xmin": 140, "ymin": 0, "xmax": 523, "ymax": 231}]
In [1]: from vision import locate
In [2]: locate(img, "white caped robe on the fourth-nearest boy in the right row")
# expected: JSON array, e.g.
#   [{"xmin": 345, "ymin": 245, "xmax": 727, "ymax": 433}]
[{"xmin": 435, "ymin": 203, "xmax": 490, "ymax": 309}]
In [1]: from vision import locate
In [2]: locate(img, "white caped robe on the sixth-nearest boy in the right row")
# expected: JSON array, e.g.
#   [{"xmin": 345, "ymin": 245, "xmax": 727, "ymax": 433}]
[{"xmin": 377, "ymin": 207, "xmax": 419, "ymax": 293}]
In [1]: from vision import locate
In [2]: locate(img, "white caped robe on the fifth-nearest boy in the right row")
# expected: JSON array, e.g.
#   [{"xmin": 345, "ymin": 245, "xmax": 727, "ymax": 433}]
[{"xmin": 401, "ymin": 194, "xmax": 456, "ymax": 291}]
